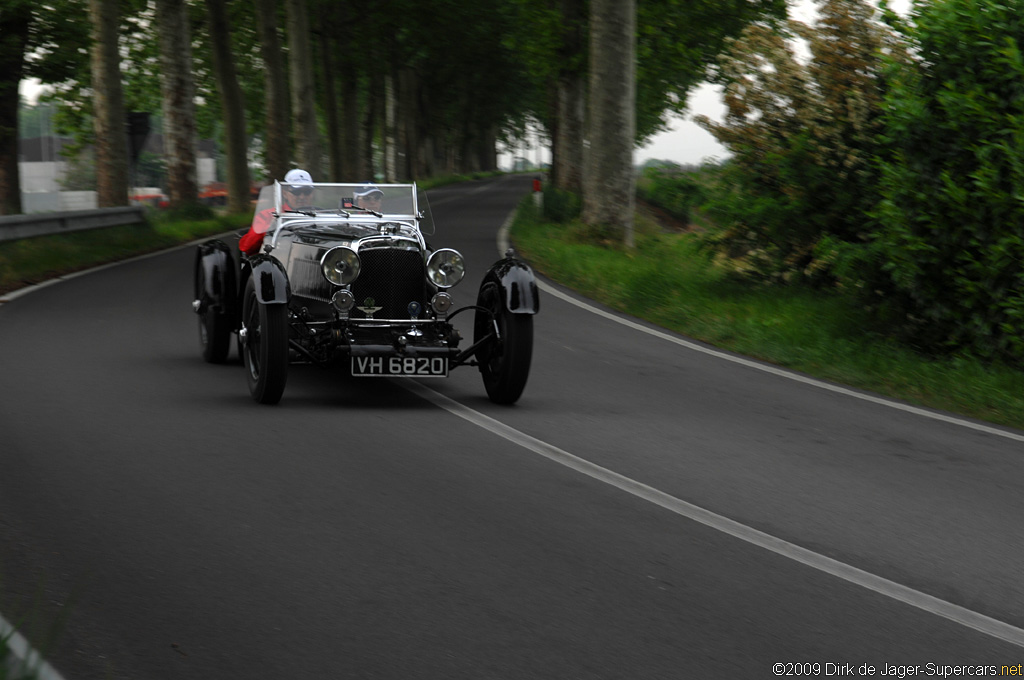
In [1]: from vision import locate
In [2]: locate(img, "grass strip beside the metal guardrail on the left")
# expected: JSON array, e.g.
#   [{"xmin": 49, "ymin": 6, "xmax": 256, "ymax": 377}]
[{"xmin": 0, "ymin": 212, "xmax": 252, "ymax": 294}]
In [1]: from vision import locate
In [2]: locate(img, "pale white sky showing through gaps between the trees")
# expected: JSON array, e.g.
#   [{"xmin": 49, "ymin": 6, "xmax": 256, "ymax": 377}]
[{"xmin": 19, "ymin": 0, "xmax": 910, "ymax": 165}]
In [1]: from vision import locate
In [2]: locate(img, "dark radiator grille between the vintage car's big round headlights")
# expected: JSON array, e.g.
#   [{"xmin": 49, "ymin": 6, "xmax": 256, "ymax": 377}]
[{"xmin": 352, "ymin": 248, "xmax": 426, "ymax": 318}]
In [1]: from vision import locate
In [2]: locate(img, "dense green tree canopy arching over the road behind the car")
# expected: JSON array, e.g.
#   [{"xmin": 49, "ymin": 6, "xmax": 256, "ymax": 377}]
[{"xmin": 0, "ymin": 0, "xmax": 785, "ymax": 218}]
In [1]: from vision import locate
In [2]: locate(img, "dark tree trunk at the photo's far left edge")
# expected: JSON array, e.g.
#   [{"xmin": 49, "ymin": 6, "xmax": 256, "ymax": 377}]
[{"xmin": 0, "ymin": 2, "xmax": 32, "ymax": 215}]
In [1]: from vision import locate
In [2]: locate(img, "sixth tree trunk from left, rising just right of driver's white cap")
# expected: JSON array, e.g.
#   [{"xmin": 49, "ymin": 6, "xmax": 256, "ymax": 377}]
[{"xmin": 286, "ymin": 0, "xmax": 324, "ymax": 181}]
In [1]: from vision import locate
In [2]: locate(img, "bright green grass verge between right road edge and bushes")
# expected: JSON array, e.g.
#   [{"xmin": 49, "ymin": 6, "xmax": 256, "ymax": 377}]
[{"xmin": 511, "ymin": 200, "xmax": 1024, "ymax": 429}]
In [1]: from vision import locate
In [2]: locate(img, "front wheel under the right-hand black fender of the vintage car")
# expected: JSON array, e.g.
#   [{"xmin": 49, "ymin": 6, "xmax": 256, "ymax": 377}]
[{"xmin": 473, "ymin": 282, "xmax": 534, "ymax": 403}]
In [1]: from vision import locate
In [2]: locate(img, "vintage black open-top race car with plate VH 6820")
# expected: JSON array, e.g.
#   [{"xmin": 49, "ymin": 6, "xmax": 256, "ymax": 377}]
[{"xmin": 193, "ymin": 182, "xmax": 540, "ymax": 403}]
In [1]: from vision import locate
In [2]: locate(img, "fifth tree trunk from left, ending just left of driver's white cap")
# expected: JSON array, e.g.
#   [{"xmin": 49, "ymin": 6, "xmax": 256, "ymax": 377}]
[{"xmin": 256, "ymin": 0, "xmax": 291, "ymax": 179}]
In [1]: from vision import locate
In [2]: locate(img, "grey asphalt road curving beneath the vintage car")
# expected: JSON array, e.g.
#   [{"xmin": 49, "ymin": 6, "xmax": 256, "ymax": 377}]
[{"xmin": 0, "ymin": 177, "xmax": 1024, "ymax": 680}]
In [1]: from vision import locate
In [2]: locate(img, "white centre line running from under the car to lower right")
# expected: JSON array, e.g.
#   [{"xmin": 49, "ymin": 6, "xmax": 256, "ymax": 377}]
[{"xmin": 396, "ymin": 378, "xmax": 1024, "ymax": 648}]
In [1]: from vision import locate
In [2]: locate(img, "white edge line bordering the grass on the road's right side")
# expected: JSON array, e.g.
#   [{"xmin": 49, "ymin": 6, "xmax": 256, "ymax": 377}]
[{"xmin": 498, "ymin": 212, "xmax": 1024, "ymax": 441}]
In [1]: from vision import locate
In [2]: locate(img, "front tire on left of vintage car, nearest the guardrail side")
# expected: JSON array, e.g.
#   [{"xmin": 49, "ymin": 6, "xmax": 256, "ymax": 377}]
[{"xmin": 242, "ymin": 279, "xmax": 288, "ymax": 403}]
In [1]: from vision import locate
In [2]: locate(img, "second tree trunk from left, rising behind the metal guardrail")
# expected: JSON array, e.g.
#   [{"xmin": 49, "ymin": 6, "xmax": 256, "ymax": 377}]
[{"xmin": 89, "ymin": 0, "xmax": 128, "ymax": 208}]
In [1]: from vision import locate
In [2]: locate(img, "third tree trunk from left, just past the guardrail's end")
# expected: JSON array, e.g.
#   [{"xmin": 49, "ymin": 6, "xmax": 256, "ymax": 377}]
[{"xmin": 157, "ymin": 0, "xmax": 199, "ymax": 207}]
